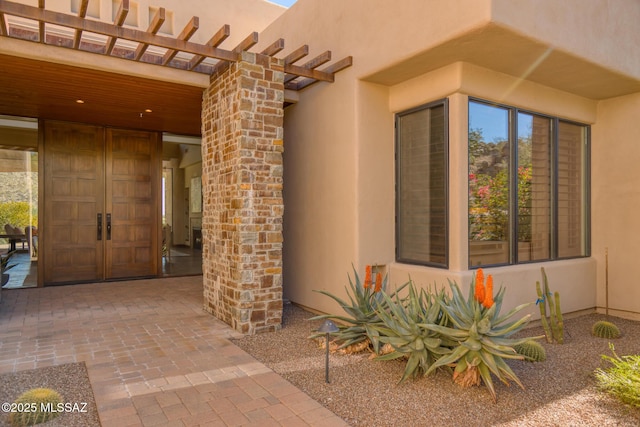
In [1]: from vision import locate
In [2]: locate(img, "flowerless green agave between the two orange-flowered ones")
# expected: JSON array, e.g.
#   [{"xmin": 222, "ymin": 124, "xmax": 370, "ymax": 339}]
[{"xmin": 371, "ymin": 282, "xmax": 455, "ymax": 382}]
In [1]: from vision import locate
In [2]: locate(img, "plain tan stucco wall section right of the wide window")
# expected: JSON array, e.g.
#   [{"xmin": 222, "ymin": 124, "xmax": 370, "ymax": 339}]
[{"xmin": 591, "ymin": 93, "xmax": 640, "ymax": 319}]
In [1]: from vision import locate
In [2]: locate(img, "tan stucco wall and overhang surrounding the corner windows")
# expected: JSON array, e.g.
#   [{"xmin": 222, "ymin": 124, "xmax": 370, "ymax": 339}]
[{"xmin": 256, "ymin": 0, "xmax": 640, "ymax": 316}]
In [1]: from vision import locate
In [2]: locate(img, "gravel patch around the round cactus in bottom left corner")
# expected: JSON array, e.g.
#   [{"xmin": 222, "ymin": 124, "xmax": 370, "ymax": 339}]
[{"xmin": 0, "ymin": 363, "xmax": 100, "ymax": 427}]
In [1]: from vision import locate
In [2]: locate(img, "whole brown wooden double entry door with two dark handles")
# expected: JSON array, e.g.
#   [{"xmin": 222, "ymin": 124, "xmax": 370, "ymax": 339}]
[{"xmin": 39, "ymin": 122, "xmax": 162, "ymax": 285}]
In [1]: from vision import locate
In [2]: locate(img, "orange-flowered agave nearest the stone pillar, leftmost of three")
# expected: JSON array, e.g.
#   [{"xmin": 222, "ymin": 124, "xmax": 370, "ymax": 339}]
[{"xmin": 309, "ymin": 266, "xmax": 408, "ymax": 353}]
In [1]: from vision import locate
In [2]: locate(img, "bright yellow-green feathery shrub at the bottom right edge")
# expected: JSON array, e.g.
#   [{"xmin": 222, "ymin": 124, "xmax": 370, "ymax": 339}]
[{"xmin": 595, "ymin": 344, "xmax": 640, "ymax": 408}]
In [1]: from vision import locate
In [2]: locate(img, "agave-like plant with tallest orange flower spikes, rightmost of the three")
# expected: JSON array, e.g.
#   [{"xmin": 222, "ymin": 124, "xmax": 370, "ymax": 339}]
[{"xmin": 420, "ymin": 270, "xmax": 541, "ymax": 401}]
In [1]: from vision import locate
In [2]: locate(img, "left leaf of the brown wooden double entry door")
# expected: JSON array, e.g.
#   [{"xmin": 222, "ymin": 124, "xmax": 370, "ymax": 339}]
[{"xmin": 40, "ymin": 122, "xmax": 104, "ymax": 284}]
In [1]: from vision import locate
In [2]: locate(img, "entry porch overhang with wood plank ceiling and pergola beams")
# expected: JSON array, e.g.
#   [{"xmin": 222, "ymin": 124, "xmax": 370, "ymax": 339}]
[{"xmin": 0, "ymin": 0, "xmax": 352, "ymax": 136}]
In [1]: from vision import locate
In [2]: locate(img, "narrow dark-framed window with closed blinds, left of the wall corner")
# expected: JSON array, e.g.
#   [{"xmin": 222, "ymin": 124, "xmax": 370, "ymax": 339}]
[{"xmin": 396, "ymin": 100, "xmax": 448, "ymax": 268}]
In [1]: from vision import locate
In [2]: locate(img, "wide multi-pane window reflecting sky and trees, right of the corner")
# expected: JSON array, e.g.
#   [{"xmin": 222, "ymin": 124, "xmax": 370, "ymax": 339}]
[{"xmin": 469, "ymin": 100, "xmax": 589, "ymax": 267}]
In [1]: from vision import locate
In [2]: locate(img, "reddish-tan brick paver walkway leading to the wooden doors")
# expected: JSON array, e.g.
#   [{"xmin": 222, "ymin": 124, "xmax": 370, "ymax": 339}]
[{"xmin": 0, "ymin": 276, "xmax": 346, "ymax": 427}]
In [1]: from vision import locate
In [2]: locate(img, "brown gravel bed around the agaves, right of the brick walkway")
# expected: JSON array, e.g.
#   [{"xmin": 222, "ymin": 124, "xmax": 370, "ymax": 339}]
[{"xmin": 234, "ymin": 304, "xmax": 640, "ymax": 427}]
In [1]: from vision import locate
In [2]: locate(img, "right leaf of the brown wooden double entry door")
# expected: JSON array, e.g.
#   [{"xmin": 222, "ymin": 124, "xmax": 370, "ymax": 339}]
[{"xmin": 106, "ymin": 129, "xmax": 161, "ymax": 279}]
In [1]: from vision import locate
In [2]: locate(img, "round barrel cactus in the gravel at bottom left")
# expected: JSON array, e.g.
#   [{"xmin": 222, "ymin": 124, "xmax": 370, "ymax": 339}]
[{"xmin": 9, "ymin": 388, "xmax": 63, "ymax": 426}]
